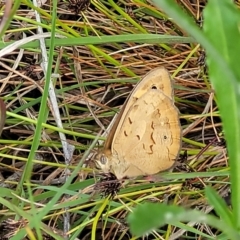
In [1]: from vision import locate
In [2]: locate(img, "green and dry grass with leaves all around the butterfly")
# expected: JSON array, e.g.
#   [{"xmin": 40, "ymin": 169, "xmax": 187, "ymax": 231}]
[{"xmin": 0, "ymin": 0, "xmax": 240, "ymax": 240}]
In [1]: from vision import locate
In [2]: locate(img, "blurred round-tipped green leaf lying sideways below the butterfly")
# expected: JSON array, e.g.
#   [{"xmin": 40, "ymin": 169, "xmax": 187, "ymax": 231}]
[{"xmin": 127, "ymin": 203, "xmax": 240, "ymax": 240}]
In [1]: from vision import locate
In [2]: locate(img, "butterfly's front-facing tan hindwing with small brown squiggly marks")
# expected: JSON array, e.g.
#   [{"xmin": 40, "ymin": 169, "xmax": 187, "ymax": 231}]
[{"xmin": 111, "ymin": 89, "xmax": 181, "ymax": 178}]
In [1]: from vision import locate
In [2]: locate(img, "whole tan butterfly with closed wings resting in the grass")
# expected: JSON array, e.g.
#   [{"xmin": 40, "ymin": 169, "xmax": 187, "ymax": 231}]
[{"xmin": 97, "ymin": 68, "xmax": 181, "ymax": 179}]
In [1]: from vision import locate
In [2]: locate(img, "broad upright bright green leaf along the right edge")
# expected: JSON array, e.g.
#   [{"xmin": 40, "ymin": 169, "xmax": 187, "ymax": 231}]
[{"xmin": 203, "ymin": 0, "xmax": 240, "ymax": 229}]
